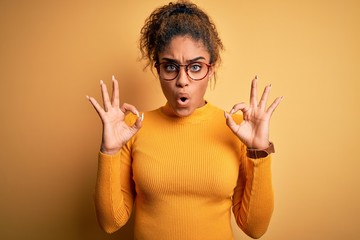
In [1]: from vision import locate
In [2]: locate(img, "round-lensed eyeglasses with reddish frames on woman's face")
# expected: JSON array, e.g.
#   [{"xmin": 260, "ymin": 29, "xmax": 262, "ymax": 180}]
[{"xmin": 155, "ymin": 62, "xmax": 212, "ymax": 81}]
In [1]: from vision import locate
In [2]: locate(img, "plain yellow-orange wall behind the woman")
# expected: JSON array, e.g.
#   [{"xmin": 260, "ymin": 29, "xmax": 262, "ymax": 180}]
[{"xmin": 0, "ymin": 0, "xmax": 360, "ymax": 240}]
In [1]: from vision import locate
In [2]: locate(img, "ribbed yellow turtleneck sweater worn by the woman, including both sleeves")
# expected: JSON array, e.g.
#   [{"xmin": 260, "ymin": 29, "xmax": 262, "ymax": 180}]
[{"xmin": 95, "ymin": 103, "xmax": 273, "ymax": 240}]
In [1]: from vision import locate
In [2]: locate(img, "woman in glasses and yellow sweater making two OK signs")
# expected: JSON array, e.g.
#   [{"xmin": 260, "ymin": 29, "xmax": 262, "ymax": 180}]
[{"xmin": 89, "ymin": 1, "xmax": 281, "ymax": 240}]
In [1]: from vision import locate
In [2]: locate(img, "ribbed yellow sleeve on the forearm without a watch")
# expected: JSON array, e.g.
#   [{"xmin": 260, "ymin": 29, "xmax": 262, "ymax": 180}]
[{"xmin": 95, "ymin": 145, "xmax": 135, "ymax": 233}]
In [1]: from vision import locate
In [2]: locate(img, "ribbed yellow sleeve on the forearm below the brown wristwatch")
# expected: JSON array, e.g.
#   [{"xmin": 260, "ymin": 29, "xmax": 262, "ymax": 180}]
[{"xmin": 233, "ymin": 148, "xmax": 274, "ymax": 238}]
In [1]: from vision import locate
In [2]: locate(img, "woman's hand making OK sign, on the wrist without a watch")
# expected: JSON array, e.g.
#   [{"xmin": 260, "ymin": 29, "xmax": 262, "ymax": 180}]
[{"xmin": 87, "ymin": 76, "xmax": 144, "ymax": 155}]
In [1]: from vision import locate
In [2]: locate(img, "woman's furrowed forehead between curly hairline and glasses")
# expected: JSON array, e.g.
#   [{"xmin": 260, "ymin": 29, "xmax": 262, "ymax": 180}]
[{"xmin": 159, "ymin": 36, "xmax": 210, "ymax": 62}]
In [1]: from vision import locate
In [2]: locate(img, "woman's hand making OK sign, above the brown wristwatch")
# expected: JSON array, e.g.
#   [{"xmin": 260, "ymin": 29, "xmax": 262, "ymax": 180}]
[{"xmin": 225, "ymin": 77, "xmax": 282, "ymax": 149}]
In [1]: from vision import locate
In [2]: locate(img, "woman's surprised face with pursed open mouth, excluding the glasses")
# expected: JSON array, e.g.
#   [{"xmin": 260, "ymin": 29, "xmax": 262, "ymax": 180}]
[{"xmin": 159, "ymin": 36, "xmax": 214, "ymax": 117}]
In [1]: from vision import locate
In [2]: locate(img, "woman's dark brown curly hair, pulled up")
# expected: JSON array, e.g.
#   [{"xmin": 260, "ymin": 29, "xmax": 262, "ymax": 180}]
[{"xmin": 140, "ymin": 0, "xmax": 224, "ymax": 71}]
